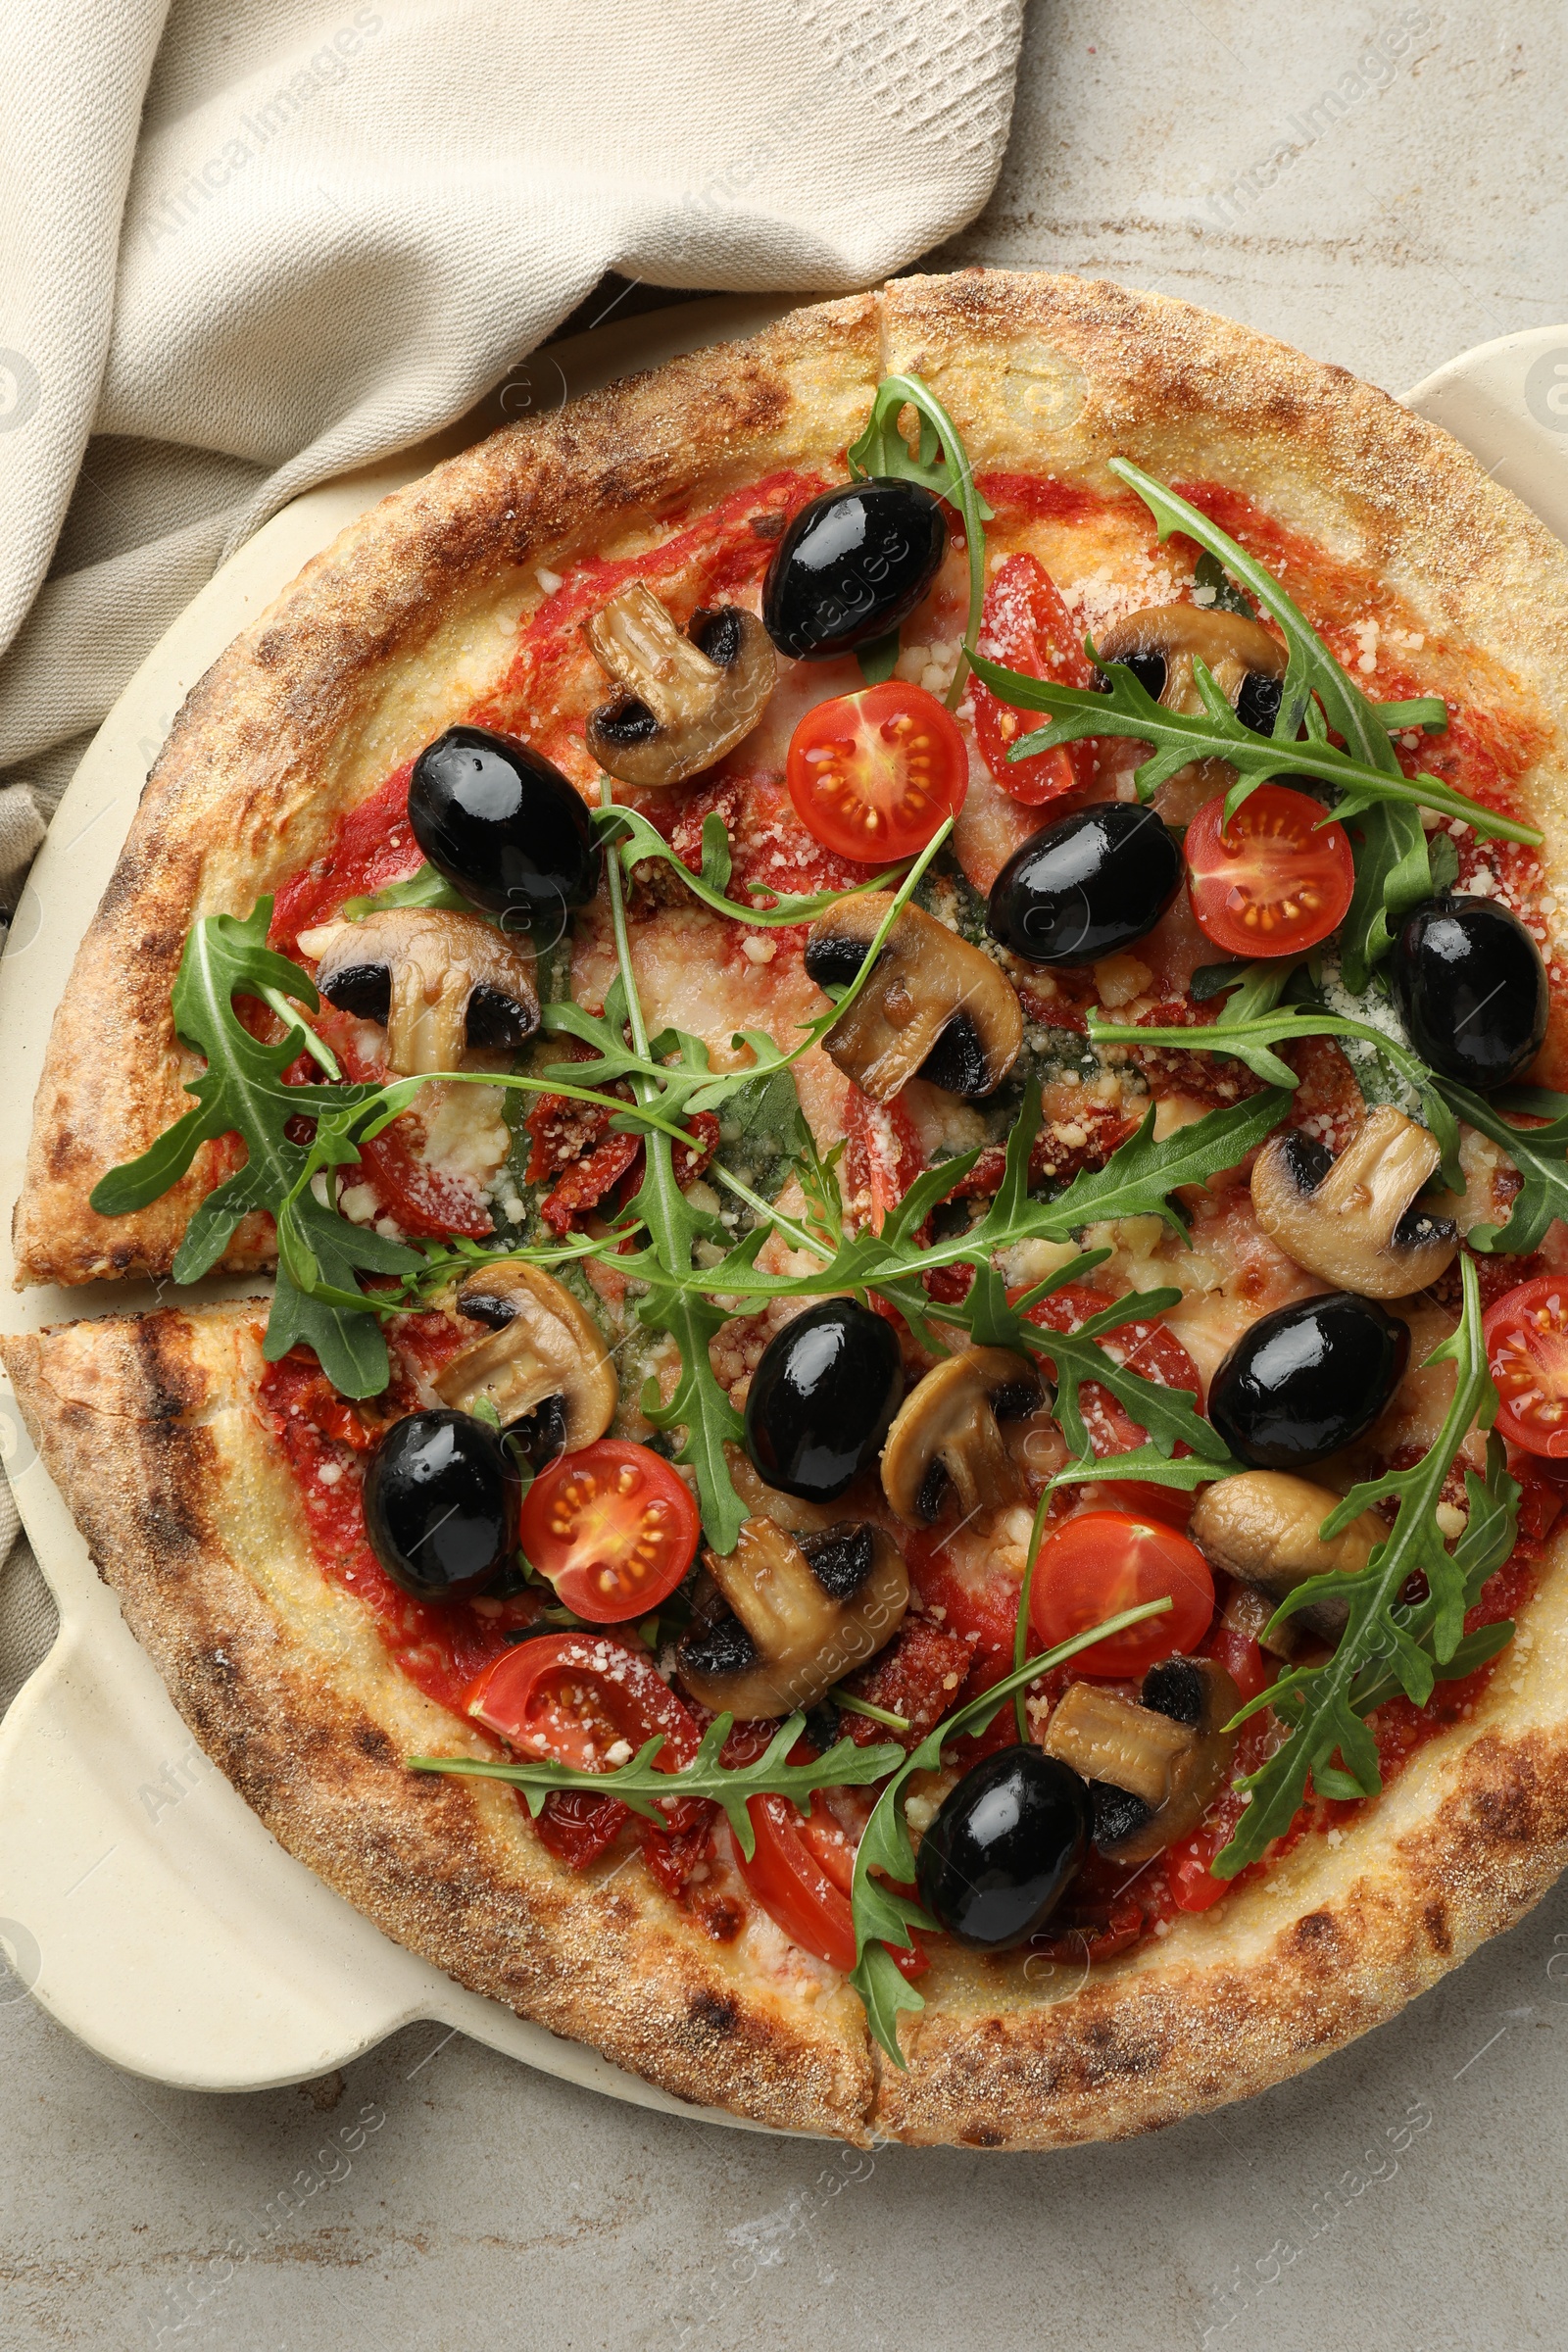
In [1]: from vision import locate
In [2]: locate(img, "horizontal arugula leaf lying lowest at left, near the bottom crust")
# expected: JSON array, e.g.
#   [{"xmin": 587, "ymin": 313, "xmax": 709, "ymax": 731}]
[{"xmin": 405, "ymin": 1715, "xmax": 903, "ymax": 1863}]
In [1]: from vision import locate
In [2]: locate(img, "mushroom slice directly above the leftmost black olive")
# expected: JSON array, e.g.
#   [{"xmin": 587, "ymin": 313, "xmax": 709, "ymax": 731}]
[{"xmin": 432, "ymin": 1258, "xmax": 620, "ymax": 1456}]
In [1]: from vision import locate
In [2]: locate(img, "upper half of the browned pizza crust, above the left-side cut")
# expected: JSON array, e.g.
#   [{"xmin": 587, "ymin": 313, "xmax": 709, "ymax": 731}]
[{"xmin": 14, "ymin": 270, "xmax": 1568, "ymax": 1284}]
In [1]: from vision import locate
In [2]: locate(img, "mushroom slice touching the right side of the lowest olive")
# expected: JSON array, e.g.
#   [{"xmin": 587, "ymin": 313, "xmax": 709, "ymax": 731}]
[{"xmin": 1042, "ymin": 1658, "xmax": 1242, "ymax": 1863}]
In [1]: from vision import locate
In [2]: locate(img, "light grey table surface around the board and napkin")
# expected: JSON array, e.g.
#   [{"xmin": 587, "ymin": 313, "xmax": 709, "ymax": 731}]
[{"xmin": 0, "ymin": 0, "xmax": 1568, "ymax": 2352}]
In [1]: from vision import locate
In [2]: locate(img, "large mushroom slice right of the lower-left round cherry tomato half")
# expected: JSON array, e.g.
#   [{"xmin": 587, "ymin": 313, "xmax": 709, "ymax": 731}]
[{"xmin": 674, "ymin": 1519, "xmax": 909, "ymax": 1722}]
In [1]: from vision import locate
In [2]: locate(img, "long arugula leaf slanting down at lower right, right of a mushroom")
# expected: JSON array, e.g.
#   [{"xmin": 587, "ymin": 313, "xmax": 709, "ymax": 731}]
[{"xmin": 1208, "ymin": 1258, "xmax": 1519, "ymax": 1880}]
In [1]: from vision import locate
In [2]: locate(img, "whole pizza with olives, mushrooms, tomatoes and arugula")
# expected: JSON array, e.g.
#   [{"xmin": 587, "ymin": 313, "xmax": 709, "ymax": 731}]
[{"xmin": 2, "ymin": 270, "xmax": 1568, "ymax": 2147}]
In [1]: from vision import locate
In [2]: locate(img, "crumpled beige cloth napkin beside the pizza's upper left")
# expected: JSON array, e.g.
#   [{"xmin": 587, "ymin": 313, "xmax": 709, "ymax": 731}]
[{"xmin": 0, "ymin": 0, "xmax": 1022, "ymax": 1705}]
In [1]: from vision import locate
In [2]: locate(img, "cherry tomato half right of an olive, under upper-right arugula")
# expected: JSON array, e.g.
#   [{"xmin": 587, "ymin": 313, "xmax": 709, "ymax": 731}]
[{"xmin": 1185, "ymin": 783, "xmax": 1356, "ymax": 955}]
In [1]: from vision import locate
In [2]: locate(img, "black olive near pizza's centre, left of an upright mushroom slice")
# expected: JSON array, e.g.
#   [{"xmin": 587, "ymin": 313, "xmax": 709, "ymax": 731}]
[{"xmin": 745, "ymin": 1298, "xmax": 903, "ymax": 1503}]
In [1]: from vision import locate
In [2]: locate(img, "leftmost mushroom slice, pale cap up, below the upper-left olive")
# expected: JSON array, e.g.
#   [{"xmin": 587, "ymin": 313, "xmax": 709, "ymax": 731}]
[{"xmin": 299, "ymin": 906, "xmax": 538, "ymax": 1077}]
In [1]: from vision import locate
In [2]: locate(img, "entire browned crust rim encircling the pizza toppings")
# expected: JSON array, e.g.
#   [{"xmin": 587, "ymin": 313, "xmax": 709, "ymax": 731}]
[{"xmin": 0, "ymin": 270, "xmax": 1568, "ymax": 2147}]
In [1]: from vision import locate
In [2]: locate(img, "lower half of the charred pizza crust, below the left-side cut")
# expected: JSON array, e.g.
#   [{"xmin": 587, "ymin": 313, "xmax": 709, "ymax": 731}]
[{"xmin": 12, "ymin": 1303, "xmax": 1568, "ymax": 2147}]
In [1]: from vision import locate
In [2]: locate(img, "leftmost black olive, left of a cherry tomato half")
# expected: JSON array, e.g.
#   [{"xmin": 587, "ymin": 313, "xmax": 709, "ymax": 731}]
[{"xmin": 365, "ymin": 1409, "xmax": 519, "ymax": 1601}]
